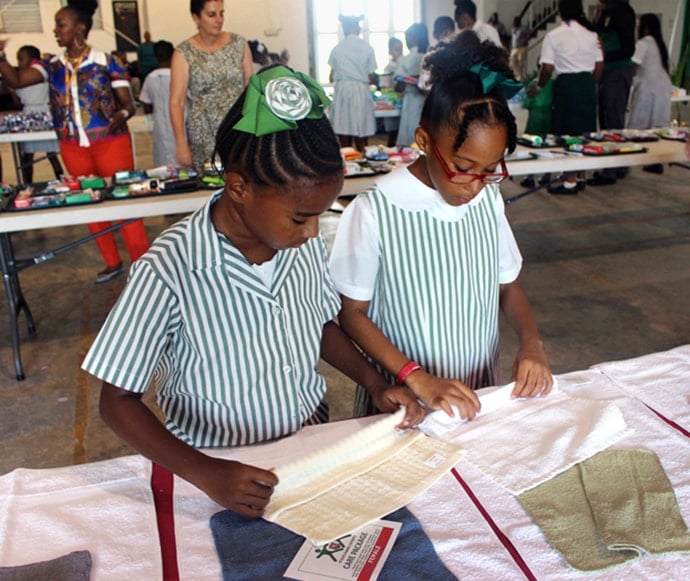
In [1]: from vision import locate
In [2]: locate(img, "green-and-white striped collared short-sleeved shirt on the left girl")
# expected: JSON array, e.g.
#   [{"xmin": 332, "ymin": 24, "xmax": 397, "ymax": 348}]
[{"xmin": 82, "ymin": 193, "xmax": 340, "ymax": 447}]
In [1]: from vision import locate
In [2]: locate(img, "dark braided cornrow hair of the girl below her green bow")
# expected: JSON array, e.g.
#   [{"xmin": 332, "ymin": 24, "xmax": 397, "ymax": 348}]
[{"xmin": 216, "ymin": 69, "xmax": 343, "ymax": 186}]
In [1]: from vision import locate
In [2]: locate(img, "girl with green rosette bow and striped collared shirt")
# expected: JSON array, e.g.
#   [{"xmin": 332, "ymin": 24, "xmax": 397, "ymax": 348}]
[{"xmin": 83, "ymin": 66, "xmax": 423, "ymax": 517}]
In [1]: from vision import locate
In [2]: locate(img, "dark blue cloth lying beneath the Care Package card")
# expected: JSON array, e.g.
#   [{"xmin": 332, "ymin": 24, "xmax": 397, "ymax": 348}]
[{"xmin": 211, "ymin": 507, "xmax": 456, "ymax": 581}]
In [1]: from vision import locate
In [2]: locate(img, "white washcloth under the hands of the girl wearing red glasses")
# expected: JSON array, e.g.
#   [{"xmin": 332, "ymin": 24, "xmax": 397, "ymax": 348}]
[{"xmin": 421, "ymin": 384, "xmax": 631, "ymax": 495}]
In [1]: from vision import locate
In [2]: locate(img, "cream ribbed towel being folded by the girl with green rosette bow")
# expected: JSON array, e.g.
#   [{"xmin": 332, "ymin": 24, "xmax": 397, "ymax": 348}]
[{"xmin": 264, "ymin": 409, "xmax": 465, "ymax": 545}]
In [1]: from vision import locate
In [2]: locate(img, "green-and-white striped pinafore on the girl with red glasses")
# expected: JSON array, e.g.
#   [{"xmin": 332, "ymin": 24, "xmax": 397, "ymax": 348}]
[{"xmin": 354, "ymin": 186, "xmax": 503, "ymax": 416}]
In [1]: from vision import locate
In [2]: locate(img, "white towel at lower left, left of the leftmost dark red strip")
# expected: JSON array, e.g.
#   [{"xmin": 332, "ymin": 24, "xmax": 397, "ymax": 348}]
[{"xmin": 0, "ymin": 456, "xmax": 162, "ymax": 581}]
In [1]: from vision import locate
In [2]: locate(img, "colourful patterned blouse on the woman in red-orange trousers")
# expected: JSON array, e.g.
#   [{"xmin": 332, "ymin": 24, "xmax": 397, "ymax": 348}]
[{"xmin": 42, "ymin": 48, "xmax": 129, "ymax": 147}]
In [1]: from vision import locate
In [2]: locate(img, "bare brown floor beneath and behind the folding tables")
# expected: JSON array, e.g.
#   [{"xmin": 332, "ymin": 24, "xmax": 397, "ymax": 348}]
[{"xmin": 0, "ymin": 118, "xmax": 690, "ymax": 474}]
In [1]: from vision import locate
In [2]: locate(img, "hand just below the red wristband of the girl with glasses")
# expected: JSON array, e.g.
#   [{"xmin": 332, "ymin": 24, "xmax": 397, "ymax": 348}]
[{"xmin": 406, "ymin": 370, "xmax": 481, "ymax": 420}]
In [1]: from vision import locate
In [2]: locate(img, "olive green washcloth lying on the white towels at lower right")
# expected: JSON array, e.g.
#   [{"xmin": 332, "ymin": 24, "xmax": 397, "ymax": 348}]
[{"xmin": 518, "ymin": 449, "xmax": 690, "ymax": 571}]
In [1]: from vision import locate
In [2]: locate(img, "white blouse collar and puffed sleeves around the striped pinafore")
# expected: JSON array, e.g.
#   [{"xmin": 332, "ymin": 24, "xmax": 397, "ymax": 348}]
[{"xmin": 329, "ymin": 163, "xmax": 522, "ymax": 301}]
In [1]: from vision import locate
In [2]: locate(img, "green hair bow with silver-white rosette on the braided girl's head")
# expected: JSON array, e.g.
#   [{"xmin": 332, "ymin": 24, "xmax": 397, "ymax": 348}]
[{"xmin": 233, "ymin": 65, "xmax": 330, "ymax": 137}]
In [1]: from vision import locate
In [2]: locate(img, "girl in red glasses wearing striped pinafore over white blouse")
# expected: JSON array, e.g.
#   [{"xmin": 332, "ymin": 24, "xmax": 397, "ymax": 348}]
[{"xmin": 330, "ymin": 31, "xmax": 553, "ymax": 419}]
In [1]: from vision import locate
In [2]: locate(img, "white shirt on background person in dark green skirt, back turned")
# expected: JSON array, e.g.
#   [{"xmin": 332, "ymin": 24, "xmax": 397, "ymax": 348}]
[{"xmin": 539, "ymin": 20, "xmax": 604, "ymax": 75}]
